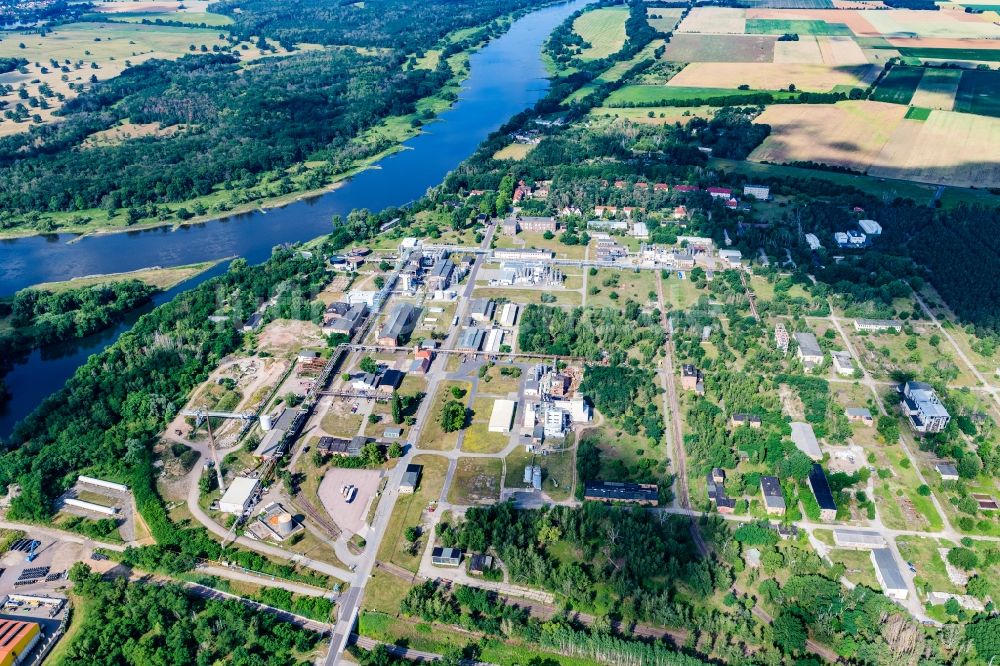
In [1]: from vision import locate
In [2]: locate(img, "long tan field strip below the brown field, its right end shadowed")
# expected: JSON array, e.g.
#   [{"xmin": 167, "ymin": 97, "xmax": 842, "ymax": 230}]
[{"xmin": 667, "ymin": 62, "xmax": 878, "ymax": 92}]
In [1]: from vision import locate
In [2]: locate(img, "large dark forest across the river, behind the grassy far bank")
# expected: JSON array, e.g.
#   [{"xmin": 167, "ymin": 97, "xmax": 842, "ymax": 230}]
[{"xmin": 0, "ymin": 49, "xmax": 451, "ymax": 227}]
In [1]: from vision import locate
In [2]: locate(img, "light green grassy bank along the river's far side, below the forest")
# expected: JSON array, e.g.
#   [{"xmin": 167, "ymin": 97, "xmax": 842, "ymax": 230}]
[{"xmin": 0, "ymin": 11, "xmax": 512, "ymax": 243}]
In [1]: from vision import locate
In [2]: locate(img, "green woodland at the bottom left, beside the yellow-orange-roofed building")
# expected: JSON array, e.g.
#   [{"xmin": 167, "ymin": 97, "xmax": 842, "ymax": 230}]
[{"xmin": 61, "ymin": 563, "xmax": 320, "ymax": 666}]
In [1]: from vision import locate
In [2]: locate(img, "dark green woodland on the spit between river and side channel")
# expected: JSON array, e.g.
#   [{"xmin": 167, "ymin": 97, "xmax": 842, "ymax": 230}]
[{"xmin": 0, "ymin": 280, "xmax": 156, "ymax": 386}]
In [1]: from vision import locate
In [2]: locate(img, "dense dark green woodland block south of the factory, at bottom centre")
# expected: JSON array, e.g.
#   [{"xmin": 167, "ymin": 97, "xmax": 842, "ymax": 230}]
[{"xmin": 438, "ymin": 502, "xmax": 731, "ymax": 626}]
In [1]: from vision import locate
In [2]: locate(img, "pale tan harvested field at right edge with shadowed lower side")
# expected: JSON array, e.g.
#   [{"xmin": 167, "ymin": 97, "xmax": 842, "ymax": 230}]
[{"xmin": 868, "ymin": 111, "xmax": 1000, "ymax": 187}]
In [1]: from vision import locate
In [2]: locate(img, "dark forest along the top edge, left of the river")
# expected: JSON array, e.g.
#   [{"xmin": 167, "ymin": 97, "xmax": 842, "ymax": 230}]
[{"xmin": 209, "ymin": 0, "xmax": 534, "ymax": 52}]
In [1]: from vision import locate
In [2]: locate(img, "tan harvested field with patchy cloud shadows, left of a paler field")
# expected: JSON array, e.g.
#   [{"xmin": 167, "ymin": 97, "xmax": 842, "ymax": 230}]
[{"xmin": 749, "ymin": 101, "xmax": 907, "ymax": 172}]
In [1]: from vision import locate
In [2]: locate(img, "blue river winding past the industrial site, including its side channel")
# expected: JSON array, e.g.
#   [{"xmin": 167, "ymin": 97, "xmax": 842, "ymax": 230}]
[{"xmin": 0, "ymin": 0, "xmax": 592, "ymax": 437}]
